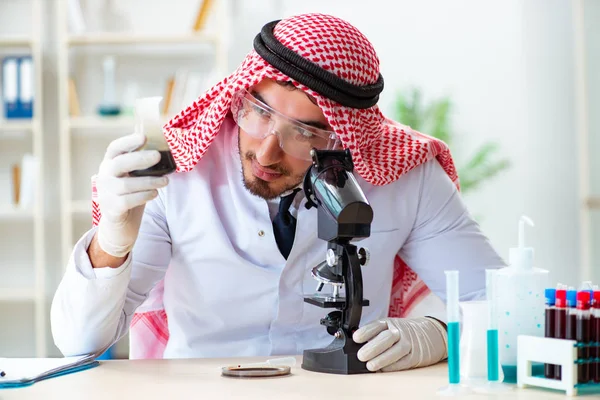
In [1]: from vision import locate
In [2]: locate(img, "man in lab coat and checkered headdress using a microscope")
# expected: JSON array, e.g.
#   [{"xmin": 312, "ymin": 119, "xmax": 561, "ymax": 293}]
[{"xmin": 51, "ymin": 14, "xmax": 504, "ymax": 371}]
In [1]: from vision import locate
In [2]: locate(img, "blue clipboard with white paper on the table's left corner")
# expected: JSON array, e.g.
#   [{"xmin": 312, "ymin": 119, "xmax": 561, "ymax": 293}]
[{"xmin": 0, "ymin": 354, "xmax": 100, "ymax": 389}]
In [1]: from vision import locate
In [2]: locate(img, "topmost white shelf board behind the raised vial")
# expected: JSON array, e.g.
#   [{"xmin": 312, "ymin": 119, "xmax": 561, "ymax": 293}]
[{"xmin": 67, "ymin": 33, "xmax": 217, "ymax": 46}]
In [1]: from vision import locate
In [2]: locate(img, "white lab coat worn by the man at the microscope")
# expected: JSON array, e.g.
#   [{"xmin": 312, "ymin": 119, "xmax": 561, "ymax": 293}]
[{"xmin": 51, "ymin": 119, "xmax": 504, "ymax": 358}]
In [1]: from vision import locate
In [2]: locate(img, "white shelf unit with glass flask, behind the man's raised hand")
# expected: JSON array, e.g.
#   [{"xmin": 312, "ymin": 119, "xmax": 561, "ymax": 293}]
[{"xmin": 56, "ymin": 0, "xmax": 228, "ymax": 290}]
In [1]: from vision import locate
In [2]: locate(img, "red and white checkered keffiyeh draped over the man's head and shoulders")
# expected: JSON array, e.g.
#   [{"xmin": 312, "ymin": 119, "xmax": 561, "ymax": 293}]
[{"xmin": 93, "ymin": 14, "xmax": 459, "ymax": 358}]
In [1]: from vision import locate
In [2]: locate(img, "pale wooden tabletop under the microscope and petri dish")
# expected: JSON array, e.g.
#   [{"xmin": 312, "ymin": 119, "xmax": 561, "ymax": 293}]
[{"xmin": 0, "ymin": 357, "xmax": 598, "ymax": 400}]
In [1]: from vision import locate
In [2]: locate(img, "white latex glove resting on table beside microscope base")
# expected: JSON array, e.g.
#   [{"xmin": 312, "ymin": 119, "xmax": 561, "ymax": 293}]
[{"xmin": 352, "ymin": 317, "xmax": 448, "ymax": 372}]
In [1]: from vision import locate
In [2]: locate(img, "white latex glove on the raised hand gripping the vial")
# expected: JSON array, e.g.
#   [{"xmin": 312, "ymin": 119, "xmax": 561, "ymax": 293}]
[{"xmin": 96, "ymin": 134, "xmax": 169, "ymax": 257}]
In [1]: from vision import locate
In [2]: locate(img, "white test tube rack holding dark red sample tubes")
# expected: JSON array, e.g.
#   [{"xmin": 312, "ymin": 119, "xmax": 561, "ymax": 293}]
[{"xmin": 517, "ymin": 335, "xmax": 600, "ymax": 396}]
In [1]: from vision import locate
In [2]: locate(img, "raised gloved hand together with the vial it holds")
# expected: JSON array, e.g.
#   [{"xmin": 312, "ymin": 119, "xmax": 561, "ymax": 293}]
[{"xmin": 92, "ymin": 97, "xmax": 175, "ymax": 263}]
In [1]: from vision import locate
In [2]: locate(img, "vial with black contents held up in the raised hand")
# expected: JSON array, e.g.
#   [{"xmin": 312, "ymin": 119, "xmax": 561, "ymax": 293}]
[{"xmin": 129, "ymin": 96, "xmax": 177, "ymax": 176}]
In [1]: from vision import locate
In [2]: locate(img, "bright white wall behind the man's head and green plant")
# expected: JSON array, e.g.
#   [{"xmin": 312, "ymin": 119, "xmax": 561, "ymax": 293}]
[{"xmin": 246, "ymin": 0, "xmax": 580, "ymax": 285}]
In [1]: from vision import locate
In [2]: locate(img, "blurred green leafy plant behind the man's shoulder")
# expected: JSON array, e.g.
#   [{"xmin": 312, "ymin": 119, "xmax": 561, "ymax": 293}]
[{"xmin": 396, "ymin": 88, "xmax": 510, "ymax": 194}]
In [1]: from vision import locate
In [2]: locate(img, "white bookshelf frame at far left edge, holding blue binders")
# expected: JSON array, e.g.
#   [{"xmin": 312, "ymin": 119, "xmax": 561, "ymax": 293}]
[{"xmin": 0, "ymin": 0, "xmax": 50, "ymax": 357}]
